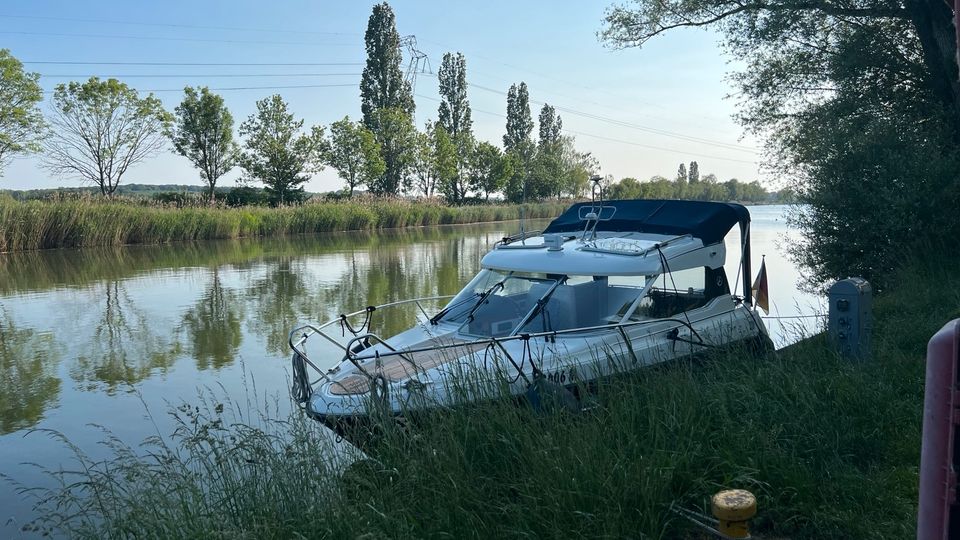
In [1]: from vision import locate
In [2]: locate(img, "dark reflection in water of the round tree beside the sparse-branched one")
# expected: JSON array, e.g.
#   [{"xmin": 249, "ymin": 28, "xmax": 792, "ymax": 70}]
[{"xmin": 183, "ymin": 267, "xmax": 244, "ymax": 369}]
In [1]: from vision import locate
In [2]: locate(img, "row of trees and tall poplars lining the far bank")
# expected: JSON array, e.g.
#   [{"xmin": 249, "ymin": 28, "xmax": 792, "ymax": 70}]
[{"xmin": 0, "ymin": 3, "xmax": 599, "ymax": 205}]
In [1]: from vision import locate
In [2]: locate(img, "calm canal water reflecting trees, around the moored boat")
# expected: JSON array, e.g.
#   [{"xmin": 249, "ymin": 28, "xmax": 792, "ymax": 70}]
[{"xmin": 0, "ymin": 206, "xmax": 823, "ymax": 538}]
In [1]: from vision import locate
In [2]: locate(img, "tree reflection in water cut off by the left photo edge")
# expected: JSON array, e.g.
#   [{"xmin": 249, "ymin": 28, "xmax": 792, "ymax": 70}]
[{"xmin": 0, "ymin": 310, "xmax": 60, "ymax": 435}]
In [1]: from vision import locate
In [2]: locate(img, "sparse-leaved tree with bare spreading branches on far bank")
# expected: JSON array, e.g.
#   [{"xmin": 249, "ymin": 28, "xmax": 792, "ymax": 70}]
[{"xmin": 44, "ymin": 77, "xmax": 173, "ymax": 196}]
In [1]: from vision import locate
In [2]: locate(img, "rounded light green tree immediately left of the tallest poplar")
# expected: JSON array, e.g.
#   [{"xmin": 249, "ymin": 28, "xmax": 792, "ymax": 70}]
[{"xmin": 324, "ymin": 116, "xmax": 387, "ymax": 197}]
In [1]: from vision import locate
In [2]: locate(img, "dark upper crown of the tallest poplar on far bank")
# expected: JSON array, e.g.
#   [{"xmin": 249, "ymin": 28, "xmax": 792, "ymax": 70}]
[{"xmin": 360, "ymin": 2, "xmax": 415, "ymax": 127}]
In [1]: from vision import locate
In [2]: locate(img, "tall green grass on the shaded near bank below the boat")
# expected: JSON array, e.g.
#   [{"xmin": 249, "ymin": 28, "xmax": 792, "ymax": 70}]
[{"xmin": 13, "ymin": 255, "xmax": 960, "ymax": 539}]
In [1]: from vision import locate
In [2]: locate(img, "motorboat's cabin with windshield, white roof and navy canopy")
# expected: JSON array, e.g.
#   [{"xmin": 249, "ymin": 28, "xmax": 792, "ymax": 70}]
[{"xmin": 432, "ymin": 200, "xmax": 749, "ymax": 338}]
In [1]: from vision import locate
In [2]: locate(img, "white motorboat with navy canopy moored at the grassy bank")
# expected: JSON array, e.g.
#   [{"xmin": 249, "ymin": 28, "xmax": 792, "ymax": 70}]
[{"xmin": 290, "ymin": 194, "xmax": 770, "ymax": 438}]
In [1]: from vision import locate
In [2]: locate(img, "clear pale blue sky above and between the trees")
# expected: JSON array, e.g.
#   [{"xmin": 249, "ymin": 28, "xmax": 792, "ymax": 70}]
[{"xmin": 0, "ymin": 0, "xmax": 760, "ymax": 191}]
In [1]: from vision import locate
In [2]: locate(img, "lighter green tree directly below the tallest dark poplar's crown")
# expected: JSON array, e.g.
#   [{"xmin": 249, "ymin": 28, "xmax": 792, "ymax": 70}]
[{"xmin": 367, "ymin": 108, "xmax": 416, "ymax": 195}]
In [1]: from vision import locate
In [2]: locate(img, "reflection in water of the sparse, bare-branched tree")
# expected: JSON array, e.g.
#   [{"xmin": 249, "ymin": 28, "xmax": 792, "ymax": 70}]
[{"xmin": 71, "ymin": 281, "xmax": 181, "ymax": 393}]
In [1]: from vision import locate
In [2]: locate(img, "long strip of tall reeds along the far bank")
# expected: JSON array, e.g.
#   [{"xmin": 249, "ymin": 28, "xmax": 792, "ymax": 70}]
[{"xmin": 0, "ymin": 196, "xmax": 568, "ymax": 252}]
